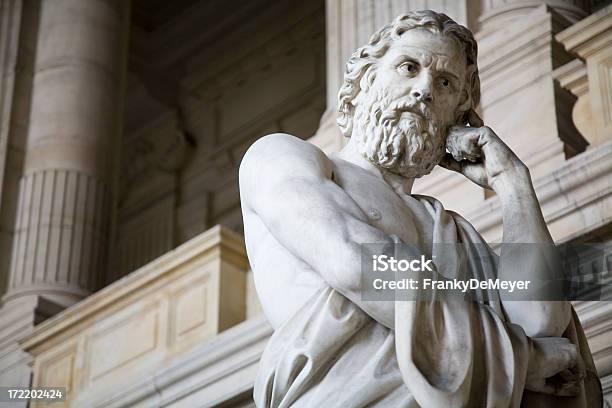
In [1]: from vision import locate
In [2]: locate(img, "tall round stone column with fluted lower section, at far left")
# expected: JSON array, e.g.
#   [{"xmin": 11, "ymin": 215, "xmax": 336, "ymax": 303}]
[{"xmin": 3, "ymin": 0, "xmax": 128, "ymax": 307}]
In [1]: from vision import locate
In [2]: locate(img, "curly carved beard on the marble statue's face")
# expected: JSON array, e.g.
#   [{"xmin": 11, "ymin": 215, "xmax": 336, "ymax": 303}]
[{"xmin": 351, "ymin": 89, "xmax": 446, "ymax": 178}]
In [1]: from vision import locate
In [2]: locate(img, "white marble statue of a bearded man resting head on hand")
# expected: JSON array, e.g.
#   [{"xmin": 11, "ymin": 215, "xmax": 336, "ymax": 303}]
[{"xmin": 240, "ymin": 11, "xmax": 602, "ymax": 408}]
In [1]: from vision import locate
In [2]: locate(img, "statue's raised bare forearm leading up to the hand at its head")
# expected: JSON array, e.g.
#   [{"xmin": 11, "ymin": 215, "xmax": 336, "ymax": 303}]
[{"xmin": 496, "ymin": 174, "xmax": 571, "ymax": 337}]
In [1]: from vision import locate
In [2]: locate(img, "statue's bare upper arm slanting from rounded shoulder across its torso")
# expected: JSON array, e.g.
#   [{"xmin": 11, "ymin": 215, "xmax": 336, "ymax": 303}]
[{"xmin": 240, "ymin": 135, "xmax": 393, "ymax": 327}]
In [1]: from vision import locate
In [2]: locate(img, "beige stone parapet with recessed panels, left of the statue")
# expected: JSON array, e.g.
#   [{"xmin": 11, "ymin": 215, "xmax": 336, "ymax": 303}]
[{"xmin": 21, "ymin": 226, "xmax": 248, "ymax": 408}]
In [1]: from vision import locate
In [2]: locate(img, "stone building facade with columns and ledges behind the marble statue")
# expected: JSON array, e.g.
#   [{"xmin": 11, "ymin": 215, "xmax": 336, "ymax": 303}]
[{"xmin": 0, "ymin": 0, "xmax": 612, "ymax": 407}]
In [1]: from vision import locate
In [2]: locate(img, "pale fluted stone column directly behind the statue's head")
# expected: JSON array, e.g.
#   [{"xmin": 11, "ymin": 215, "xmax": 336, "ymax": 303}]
[{"xmin": 310, "ymin": 0, "xmax": 468, "ymax": 153}]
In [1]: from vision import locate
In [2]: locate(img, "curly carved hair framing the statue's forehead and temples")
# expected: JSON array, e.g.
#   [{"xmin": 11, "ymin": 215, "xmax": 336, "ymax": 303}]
[{"xmin": 337, "ymin": 10, "xmax": 480, "ymax": 137}]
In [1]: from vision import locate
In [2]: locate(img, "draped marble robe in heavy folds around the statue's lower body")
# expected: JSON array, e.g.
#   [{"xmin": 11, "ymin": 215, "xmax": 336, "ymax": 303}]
[{"xmin": 254, "ymin": 195, "xmax": 602, "ymax": 408}]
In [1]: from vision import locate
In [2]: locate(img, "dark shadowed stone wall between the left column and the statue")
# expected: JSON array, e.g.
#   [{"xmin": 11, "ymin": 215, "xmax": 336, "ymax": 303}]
[{"xmin": 114, "ymin": 1, "xmax": 325, "ymax": 281}]
